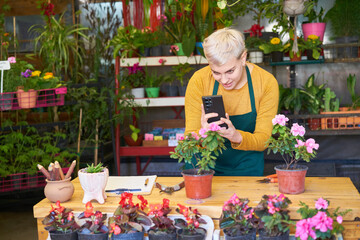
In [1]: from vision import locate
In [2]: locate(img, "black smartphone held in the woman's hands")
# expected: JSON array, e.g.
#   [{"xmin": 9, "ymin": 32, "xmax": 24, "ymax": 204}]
[{"xmin": 202, "ymin": 95, "xmax": 228, "ymax": 129}]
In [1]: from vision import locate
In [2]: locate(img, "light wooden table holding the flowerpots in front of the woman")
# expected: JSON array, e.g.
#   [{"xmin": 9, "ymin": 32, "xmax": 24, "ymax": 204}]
[{"xmin": 34, "ymin": 177, "xmax": 360, "ymax": 240}]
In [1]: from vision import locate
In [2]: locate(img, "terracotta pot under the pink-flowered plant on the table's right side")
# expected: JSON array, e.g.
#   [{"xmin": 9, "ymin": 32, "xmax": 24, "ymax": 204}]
[{"xmin": 275, "ymin": 165, "xmax": 308, "ymax": 194}]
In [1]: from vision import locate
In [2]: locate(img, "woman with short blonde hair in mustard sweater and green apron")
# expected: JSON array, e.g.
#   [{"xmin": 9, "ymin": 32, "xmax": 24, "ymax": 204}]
[{"xmin": 185, "ymin": 28, "xmax": 279, "ymax": 176}]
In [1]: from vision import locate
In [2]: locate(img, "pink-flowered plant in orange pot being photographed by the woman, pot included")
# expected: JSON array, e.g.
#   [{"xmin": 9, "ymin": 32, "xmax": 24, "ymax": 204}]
[{"xmin": 170, "ymin": 123, "xmax": 225, "ymax": 199}]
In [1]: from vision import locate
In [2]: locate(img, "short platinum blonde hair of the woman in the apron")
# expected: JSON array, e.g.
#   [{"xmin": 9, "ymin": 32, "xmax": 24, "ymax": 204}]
[{"xmin": 203, "ymin": 28, "xmax": 246, "ymax": 65}]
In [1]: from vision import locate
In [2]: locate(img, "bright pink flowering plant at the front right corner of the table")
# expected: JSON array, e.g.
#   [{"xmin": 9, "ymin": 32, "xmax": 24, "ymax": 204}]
[{"xmin": 295, "ymin": 198, "xmax": 351, "ymax": 240}]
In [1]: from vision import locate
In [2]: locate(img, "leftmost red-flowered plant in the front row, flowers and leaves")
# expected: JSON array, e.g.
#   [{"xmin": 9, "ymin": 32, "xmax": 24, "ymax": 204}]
[{"xmin": 42, "ymin": 201, "xmax": 80, "ymax": 233}]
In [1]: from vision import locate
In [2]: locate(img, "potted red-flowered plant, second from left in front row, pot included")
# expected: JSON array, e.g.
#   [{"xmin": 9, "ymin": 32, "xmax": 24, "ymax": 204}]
[{"xmin": 78, "ymin": 202, "xmax": 109, "ymax": 240}]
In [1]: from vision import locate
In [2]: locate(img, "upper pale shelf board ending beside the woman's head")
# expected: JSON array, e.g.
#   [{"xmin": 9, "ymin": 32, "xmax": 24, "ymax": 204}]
[{"xmin": 120, "ymin": 55, "xmax": 208, "ymax": 67}]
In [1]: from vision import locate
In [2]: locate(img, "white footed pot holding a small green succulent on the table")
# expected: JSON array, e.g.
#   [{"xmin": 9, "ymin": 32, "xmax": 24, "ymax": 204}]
[{"xmin": 78, "ymin": 168, "xmax": 109, "ymax": 204}]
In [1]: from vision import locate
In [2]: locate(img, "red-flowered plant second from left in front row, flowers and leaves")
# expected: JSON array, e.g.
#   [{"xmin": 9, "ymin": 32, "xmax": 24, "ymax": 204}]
[{"xmin": 78, "ymin": 202, "xmax": 109, "ymax": 234}]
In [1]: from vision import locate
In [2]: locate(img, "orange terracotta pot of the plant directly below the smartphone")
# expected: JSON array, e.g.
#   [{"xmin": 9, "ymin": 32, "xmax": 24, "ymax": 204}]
[{"xmin": 181, "ymin": 169, "xmax": 215, "ymax": 199}]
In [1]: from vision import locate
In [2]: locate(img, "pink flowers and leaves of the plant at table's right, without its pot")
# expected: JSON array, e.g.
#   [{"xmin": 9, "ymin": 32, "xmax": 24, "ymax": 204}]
[{"xmin": 266, "ymin": 114, "xmax": 319, "ymax": 169}]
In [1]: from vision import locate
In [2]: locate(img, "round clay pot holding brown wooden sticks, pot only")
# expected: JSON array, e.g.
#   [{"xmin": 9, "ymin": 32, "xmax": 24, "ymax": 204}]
[{"xmin": 44, "ymin": 178, "xmax": 74, "ymax": 202}]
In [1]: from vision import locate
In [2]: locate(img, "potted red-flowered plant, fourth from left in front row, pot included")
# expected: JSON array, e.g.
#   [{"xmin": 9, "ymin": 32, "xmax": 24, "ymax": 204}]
[{"xmin": 148, "ymin": 198, "xmax": 176, "ymax": 240}]
